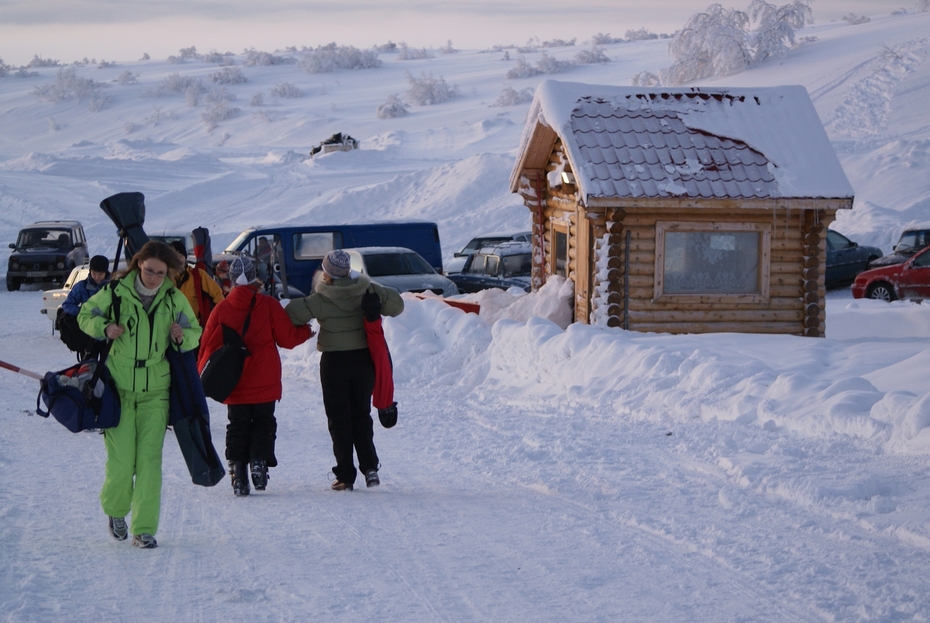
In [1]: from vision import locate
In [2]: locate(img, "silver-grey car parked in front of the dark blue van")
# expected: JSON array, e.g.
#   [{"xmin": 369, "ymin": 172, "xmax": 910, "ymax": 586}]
[{"xmin": 345, "ymin": 247, "xmax": 458, "ymax": 296}]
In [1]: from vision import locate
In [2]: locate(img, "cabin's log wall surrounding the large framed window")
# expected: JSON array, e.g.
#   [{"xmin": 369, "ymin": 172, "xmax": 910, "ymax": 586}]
[{"xmin": 588, "ymin": 208, "xmax": 832, "ymax": 336}]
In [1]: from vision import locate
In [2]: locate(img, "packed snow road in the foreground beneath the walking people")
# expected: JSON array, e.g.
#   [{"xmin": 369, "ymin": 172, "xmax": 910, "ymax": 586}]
[{"xmin": 0, "ymin": 291, "xmax": 930, "ymax": 622}]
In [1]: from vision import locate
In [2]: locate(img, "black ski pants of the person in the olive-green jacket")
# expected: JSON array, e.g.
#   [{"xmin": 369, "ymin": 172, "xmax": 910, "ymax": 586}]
[{"xmin": 320, "ymin": 348, "xmax": 378, "ymax": 484}]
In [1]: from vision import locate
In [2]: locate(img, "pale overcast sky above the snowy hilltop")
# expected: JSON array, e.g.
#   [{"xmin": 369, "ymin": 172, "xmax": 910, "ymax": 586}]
[{"xmin": 0, "ymin": 0, "xmax": 892, "ymax": 66}]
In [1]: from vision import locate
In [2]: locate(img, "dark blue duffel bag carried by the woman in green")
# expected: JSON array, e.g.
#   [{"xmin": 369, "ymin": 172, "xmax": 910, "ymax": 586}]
[{"xmin": 36, "ymin": 360, "xmax": 120, "ymax": 433}]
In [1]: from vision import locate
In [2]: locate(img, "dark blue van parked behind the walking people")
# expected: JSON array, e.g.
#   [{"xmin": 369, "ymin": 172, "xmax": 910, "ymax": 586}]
[{"xmin": 223, "ymin": 221, "xmax": 442, "ymax": 298}]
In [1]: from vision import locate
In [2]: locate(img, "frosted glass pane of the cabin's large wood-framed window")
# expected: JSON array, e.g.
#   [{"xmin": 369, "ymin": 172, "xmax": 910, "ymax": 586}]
[{"xmin": 663, "ymin": 232, "xmax": 760, "ymax": 294}]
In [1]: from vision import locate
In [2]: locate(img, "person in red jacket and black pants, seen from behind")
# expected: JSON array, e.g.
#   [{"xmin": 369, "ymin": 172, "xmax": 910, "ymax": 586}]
[{"xmin": 197, "ymin": 257, "xmax": 313, "ymax": 496}]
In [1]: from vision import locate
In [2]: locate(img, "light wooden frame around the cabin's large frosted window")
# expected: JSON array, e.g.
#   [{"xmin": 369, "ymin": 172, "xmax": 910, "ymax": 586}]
[{"xmin": 653, "ymin": 221, "xmax": 772, "ymax": 303}]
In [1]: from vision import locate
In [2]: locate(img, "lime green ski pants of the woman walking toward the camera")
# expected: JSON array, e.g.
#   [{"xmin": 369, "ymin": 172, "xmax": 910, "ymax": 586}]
[{"xmin": 100, "ymin": 389, "xmax": 168, "ymax": 535}]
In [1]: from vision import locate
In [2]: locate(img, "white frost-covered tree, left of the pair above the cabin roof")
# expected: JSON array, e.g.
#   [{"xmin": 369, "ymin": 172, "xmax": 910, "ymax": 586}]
[{"xmin": 659, "ymin": 4, "xmax": 752, "ymax": 85}]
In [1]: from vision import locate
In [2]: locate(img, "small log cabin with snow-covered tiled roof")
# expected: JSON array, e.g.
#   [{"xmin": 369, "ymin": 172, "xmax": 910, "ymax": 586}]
[{"xmin": 510, "ymin": 80, "xmax": 853, "ymax": 337}]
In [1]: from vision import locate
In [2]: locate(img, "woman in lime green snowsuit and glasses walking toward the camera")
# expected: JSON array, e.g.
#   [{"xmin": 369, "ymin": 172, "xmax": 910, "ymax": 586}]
[{"xmin": 78, "ymin": 241, "xmax": 201, "ymax": 549}]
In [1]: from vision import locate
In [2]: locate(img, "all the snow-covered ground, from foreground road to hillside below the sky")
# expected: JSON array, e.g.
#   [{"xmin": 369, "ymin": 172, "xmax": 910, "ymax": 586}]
[{"xmin": 0, "ymin": 6, "xmax": 930, "ymax": 622}]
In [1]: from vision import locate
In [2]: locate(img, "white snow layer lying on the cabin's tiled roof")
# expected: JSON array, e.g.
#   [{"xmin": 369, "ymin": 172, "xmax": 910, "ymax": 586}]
[{"xmin": 517, "ymin": 80, "xmax": 854, "ymax": 198}]
